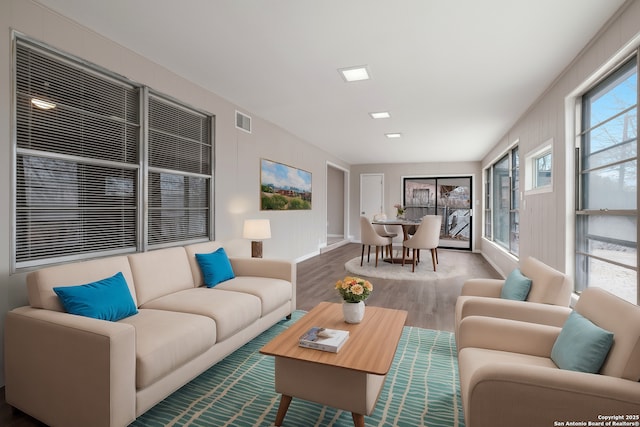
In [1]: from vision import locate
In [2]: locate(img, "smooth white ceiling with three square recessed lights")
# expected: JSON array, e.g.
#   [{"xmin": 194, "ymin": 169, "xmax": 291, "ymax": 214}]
[{"xmin": 37, "ymin": 0, "xmax": 624, "ymax": 164}]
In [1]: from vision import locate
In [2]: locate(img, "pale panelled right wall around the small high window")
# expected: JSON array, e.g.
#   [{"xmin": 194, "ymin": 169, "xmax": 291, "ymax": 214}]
[{"xmin": 479, "ymin": 1, "xmax": 640, "ymax": 275}]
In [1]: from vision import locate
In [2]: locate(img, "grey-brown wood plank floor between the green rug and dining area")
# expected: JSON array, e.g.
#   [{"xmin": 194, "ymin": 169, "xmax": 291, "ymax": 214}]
[{"xmin": 0, "ymin": 243, "xmax": 500, "ymax": 427}]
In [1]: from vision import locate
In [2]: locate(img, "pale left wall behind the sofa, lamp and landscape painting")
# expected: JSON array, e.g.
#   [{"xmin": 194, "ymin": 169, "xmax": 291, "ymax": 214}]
[{"xmin": 0, "ymin": 0, "xmax": 348, "ymax": 385}]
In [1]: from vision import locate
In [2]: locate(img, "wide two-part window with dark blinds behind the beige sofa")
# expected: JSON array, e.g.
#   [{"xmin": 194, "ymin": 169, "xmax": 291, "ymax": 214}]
[{"xmin": 12, "ymin": 36, "xmax": 212, "ymax": 270}]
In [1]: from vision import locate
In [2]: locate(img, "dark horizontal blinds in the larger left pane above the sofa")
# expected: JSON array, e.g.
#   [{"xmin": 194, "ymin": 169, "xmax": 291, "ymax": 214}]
[{"xmin": 15, "ymin": 40, "xmax": 140, "ymax": 268}]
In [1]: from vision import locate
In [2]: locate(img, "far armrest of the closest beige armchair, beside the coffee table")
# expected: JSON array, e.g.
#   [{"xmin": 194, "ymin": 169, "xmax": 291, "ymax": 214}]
[{"xmin": 456, "ymin": 316, "xmax": 562, "ymax": 357}]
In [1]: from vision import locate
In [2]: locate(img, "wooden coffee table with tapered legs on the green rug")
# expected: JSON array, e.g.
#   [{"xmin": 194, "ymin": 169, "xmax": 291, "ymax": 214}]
[{"xmin": 260, "ymin": 302, "xmax": 407, "ymax": 427}]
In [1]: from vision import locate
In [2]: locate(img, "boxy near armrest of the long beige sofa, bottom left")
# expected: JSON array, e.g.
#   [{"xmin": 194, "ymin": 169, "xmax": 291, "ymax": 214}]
[{"xmin": 4, "ymin": 307, "xmax": 136, "ymax": 426}]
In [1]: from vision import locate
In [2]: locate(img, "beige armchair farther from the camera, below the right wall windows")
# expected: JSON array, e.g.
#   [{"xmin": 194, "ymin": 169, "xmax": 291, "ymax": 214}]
[{"xmin": 455, "ymin": 257, "xmax": 573, "ymax": 331}]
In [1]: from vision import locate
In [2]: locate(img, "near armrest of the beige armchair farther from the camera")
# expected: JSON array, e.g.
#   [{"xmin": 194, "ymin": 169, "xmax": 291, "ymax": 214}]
[{"xmin": 455, "ymin": 296, "xmax": 571, "ymax": 340}]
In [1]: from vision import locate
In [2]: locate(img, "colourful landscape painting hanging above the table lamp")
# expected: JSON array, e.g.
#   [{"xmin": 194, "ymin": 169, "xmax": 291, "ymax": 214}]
[{"xmin": 260, "ymin": 159, "xmax": 311, "ymax": 211}]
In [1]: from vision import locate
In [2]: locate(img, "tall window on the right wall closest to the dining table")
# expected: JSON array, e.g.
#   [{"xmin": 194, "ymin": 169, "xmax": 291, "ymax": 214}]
[{"xmin": 484, "ymin": 147, "xmax": 520, "ymax": 255}]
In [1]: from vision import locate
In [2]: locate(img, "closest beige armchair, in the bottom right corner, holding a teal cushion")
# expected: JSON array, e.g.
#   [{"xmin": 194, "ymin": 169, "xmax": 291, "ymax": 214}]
[{"xmin": 456, "ymin": 288, "xmax": 640, "ymax": 427}]
